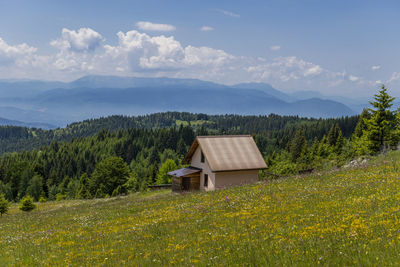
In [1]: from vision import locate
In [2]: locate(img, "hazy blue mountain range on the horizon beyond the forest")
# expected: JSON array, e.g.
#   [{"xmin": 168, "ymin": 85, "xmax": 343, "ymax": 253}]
[{"xmin": 0, "ymin": 75, "xmax": 367, "ymax": 128}]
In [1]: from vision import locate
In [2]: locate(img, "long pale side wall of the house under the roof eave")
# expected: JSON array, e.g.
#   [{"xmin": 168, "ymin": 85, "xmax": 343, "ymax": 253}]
[{"xmin": 215, "ymin": 170, "xmax": 258, "ymax": 188}]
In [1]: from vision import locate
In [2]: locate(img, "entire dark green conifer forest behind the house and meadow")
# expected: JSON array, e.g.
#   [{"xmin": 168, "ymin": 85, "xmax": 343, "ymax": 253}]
[{"xmin": 0, "ymin": 87, "xmax": 400, "ymax": 201}]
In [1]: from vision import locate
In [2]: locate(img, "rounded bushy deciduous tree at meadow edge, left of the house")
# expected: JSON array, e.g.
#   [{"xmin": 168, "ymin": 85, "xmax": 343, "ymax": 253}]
[{"xmin": 89, "ymin": 157, "xmax": 129, "ymax": 197}]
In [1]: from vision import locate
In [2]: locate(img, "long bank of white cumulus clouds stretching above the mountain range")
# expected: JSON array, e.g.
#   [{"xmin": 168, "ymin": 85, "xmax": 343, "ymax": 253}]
[{"xmin": 0, "ymin": 28, "xmax": 384, "ymax": 93}]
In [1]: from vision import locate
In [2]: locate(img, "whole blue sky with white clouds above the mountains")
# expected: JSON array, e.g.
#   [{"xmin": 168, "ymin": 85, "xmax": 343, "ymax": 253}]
[{"xmin": 0, "ymin": 0, "xmax": 400, "ymax": 96}]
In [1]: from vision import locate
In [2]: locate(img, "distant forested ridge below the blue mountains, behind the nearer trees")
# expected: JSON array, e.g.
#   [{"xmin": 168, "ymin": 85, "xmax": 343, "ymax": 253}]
[{"xmin": 0, "ymin": 112, "xmax": 358, "ymax": 154}]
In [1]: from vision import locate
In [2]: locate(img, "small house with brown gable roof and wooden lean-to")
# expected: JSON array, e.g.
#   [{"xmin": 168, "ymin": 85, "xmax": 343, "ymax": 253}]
[{"xmin": 168, "ymin": 135, "xmax": 267, "ymax": 192}]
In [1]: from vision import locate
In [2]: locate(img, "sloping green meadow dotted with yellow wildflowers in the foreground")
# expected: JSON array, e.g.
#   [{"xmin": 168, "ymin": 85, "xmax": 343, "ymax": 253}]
[{"xmin": 0, "ymin": 152, "xmax": 400, "ymax": 266}]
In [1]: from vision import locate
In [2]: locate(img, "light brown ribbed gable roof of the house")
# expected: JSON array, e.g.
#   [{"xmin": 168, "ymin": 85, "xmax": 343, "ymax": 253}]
[{"xmin": 184, "ymin": 135, "xmax": 267, "ymax": 172}]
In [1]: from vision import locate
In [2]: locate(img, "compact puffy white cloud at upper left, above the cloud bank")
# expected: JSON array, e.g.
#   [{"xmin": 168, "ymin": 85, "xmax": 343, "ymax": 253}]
[{"xmin": 50, "ymin": 28, "xmax": 103, "ymax": 52}]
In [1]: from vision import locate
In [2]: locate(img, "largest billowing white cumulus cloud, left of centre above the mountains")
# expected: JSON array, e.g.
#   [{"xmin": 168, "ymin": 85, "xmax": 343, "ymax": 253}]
[{"xmin": 99, "ymin": 30, "xmax": 232, "ymax": 71}]
